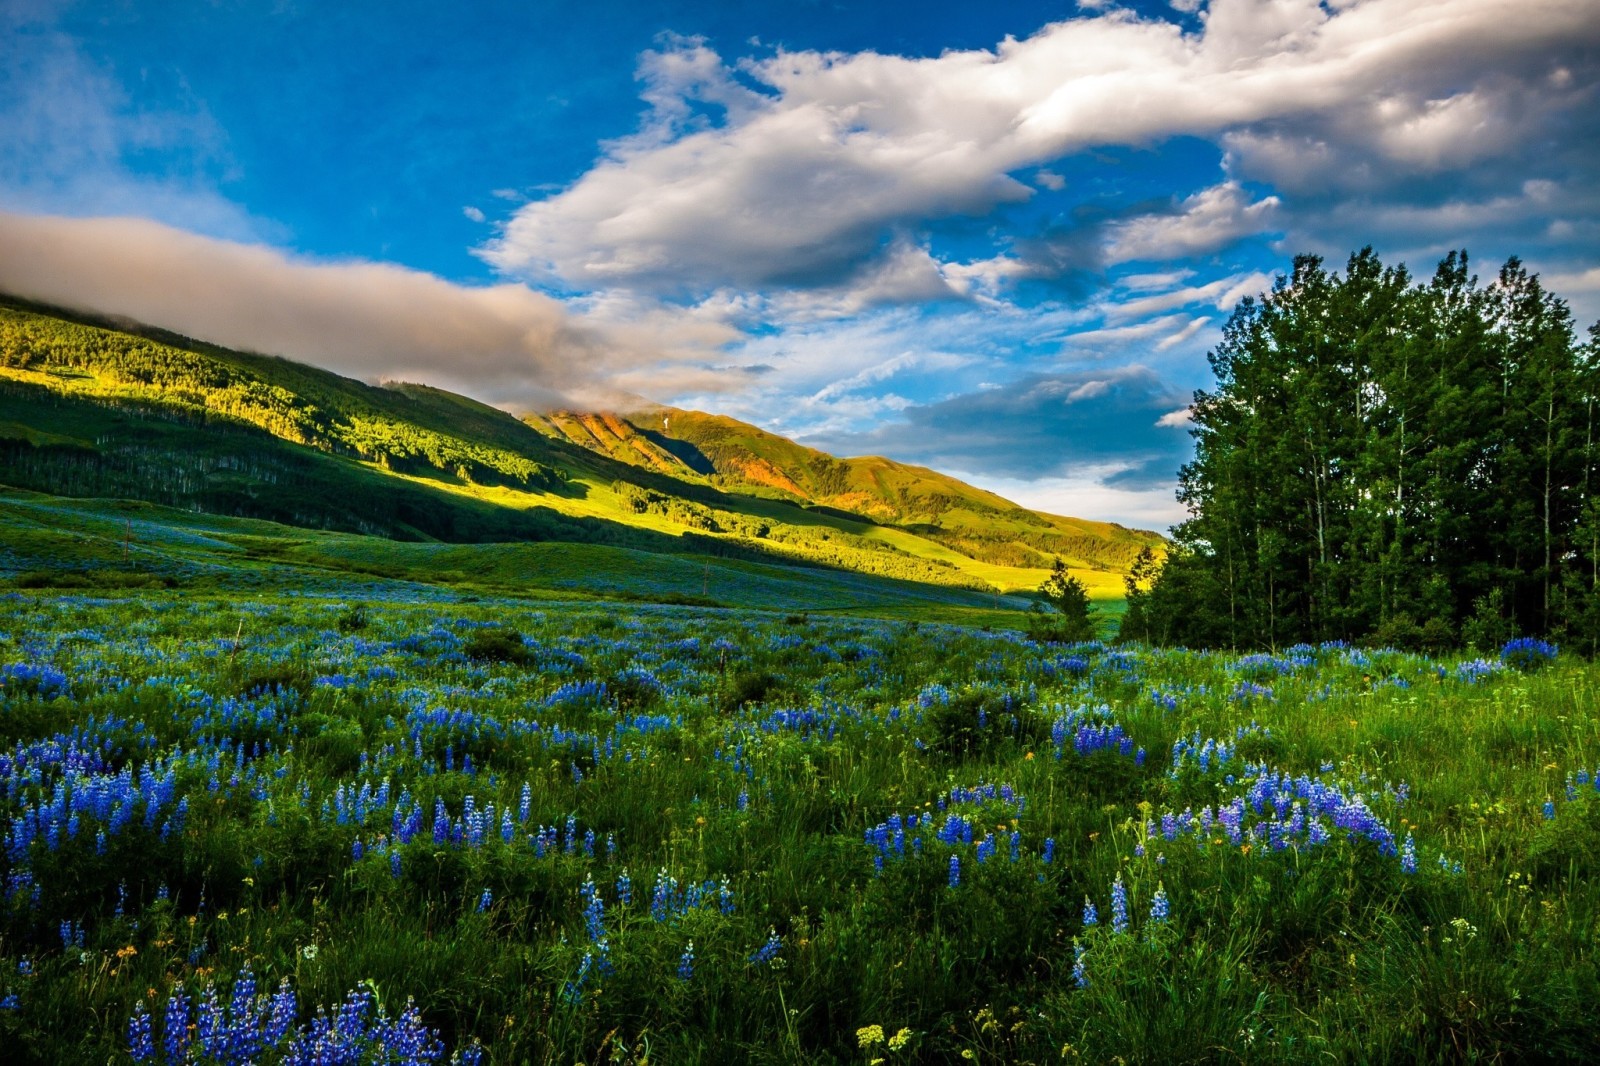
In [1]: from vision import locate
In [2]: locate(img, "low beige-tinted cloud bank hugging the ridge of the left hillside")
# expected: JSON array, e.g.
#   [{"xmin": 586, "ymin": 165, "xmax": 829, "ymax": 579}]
[{"xmin": 0, "ymin": 213, "xmax": 725, "ymax": 407}]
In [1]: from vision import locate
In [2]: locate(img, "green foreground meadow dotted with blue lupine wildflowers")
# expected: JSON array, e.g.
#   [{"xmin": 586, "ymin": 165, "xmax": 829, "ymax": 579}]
[{"xmin": 0, "ymin": 578, "xmax": 1600, "ymax": 1063}]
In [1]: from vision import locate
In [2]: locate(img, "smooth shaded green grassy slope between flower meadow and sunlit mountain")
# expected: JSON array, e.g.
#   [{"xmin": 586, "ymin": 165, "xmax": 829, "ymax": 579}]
[{"xmin": 0, "ymin": 490, "xmax": 1027, "ymax": 627}]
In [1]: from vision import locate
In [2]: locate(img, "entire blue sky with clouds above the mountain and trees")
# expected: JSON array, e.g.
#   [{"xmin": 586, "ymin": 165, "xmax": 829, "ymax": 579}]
[{"xmin": 0, "ymin": 0, "xmax": 1600, "ymax": 528}]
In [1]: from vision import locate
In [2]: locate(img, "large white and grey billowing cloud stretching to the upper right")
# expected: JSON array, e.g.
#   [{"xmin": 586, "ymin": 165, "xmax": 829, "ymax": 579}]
[{"xmin": 483, "ymin": 0, "xmax": 1600, "ymax": 295}]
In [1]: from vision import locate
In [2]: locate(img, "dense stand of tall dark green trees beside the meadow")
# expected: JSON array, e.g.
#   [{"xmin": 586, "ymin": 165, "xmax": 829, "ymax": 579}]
[{"xmin": 1128, "ymin": 248, "xmax": 1600, "ymax": 651}]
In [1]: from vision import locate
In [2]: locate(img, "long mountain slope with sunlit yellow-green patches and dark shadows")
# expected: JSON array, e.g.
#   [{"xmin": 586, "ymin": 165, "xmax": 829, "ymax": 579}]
[{"xmin": 0, "ymin": 299, "xmax": 1162, "ymax": 597}]
